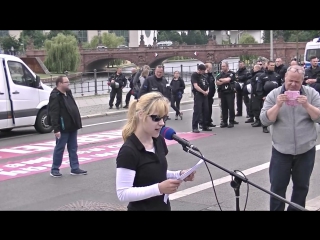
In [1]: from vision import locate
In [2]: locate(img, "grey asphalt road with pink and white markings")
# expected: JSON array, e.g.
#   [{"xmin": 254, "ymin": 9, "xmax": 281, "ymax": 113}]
[{"xmin": 0, "ymin": 102, "xmax": 320, "ymax": 211}]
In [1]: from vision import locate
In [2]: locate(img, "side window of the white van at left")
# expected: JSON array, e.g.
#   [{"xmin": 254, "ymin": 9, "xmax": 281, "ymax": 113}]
[{"xmin": 8, "ymin": 61, "xmax": 35, "ymax": 87}]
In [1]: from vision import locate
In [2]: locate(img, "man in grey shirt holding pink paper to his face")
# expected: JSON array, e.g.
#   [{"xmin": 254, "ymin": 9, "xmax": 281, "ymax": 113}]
[{"xmin": 260, "ymin": 66, "xmax": 320, "ymax": 211}]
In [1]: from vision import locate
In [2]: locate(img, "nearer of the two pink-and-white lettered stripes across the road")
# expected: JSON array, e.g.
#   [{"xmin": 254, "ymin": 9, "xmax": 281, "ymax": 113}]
[{"xmin": 0, "ymin": 133, "xmax": 213, "ymax": 181}]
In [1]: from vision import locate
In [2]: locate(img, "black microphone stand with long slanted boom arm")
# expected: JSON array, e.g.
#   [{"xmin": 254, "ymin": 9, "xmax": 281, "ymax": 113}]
[{"xmin": 180, "ymin": 143, "xmax": 308, "ymax": 211}]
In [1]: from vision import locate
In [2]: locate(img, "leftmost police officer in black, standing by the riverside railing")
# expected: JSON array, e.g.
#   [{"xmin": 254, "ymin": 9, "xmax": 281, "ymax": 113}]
[{"xmin": 108, "ymin": 68, "xmax": 127, "ymax": 109}]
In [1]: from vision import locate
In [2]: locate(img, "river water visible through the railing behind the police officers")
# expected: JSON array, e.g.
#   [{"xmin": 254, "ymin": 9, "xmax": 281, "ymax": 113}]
[{"xmin": 45, "ymin": 60, "xmax": 238, "ymax": 97}]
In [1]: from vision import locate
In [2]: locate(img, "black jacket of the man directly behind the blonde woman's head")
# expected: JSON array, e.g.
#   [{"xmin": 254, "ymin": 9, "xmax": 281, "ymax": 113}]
[{"xmin": 138, "ymin": 75, "xmax": 171, "ymax": 99}]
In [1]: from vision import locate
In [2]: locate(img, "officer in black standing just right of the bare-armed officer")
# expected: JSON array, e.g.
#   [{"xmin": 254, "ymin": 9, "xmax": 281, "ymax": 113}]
[{"xmin": 236, "ymin": 61, "xmax": 251, "ymax": 117}]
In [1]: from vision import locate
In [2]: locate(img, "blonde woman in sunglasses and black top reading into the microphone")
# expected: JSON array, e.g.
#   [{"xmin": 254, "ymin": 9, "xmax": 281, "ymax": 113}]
[{"xmin": 116, "ymin": 92, "xmax": 195, "ymax": 211}]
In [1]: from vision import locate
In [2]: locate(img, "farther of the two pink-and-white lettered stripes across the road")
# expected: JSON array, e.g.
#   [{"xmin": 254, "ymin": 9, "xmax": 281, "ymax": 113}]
[{"xmin": 0, "ymin": 130, "xmax": 122, "ymax": 160}]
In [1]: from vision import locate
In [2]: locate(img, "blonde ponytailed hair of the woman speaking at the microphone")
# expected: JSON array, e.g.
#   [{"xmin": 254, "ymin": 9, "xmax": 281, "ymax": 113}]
[{"xmin": 122, "ymin": 92, "xmax": 169, "ymax": 142}]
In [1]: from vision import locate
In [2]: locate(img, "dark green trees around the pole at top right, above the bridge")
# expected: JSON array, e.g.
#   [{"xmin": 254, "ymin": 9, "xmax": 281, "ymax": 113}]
[{"xmin": 263, "ymin": 30, "xmax": 320, "ymax": 43}]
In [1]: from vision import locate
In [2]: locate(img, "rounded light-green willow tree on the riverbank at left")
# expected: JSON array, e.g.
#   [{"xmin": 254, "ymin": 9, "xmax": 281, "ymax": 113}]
[{"xmin": 44, "ymin": 33, "xmax": 80, "ymax": 73}]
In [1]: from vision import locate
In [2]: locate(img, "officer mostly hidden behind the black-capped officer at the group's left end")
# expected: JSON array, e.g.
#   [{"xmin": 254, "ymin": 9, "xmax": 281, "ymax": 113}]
[{"xmin": 199, "ymin": 63, "xmax": 216, "ymax": 128}]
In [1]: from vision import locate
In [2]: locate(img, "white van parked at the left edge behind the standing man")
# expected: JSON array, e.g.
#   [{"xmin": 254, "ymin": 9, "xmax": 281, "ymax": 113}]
[{"xmin": 0, "ymin": 54, "xmax": 53, "ymax": 133}]
